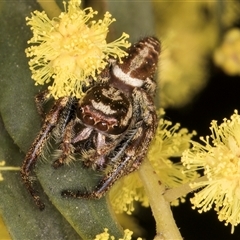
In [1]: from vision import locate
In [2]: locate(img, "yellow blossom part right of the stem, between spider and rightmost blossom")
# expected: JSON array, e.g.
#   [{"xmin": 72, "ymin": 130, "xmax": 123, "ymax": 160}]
[{"xmin": 148, "ymin": 118, "xmax": 196, "ymax": 187}]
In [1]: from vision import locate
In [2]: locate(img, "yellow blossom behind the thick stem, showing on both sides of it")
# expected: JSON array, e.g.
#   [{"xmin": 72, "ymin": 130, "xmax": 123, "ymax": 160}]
[{"xmin": 110, "ymin": 110, "xmax": 198, "ymax": 214}]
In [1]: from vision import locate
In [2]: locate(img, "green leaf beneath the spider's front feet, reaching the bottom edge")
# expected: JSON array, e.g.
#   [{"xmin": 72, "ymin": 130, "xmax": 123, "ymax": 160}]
[{"xmin": 37, "ymin": 158, "xmax": 122, "ymax": 239}]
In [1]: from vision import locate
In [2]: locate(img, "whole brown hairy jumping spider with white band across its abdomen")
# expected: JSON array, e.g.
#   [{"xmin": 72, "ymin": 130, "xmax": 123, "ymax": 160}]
[{"xmin": 21, "ymin": 37, "xmax": 160, "ymax": 210}]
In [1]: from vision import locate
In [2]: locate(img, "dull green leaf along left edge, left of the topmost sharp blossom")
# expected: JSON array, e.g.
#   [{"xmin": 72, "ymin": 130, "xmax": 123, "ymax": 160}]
[{"xmin": 0, "ymin": 1, "xmax": 40, "ymax": 151}]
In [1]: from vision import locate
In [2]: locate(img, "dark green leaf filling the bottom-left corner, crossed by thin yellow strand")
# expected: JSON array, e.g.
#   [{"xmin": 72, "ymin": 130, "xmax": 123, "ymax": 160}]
[{"xmin": 0, "ymin": 115, "xmax": 80, "ymax": 240}]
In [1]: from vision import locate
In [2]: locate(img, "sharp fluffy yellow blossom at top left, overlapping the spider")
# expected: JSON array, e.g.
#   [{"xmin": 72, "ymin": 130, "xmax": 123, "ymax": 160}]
[{"xmin": 26, "ymin": 0, "xmax": 130, "ymax": 98}]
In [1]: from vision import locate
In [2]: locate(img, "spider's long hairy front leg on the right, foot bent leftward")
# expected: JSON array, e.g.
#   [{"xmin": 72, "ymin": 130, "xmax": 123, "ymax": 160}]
[{"xmin": 62, "ymin": 89, "xmax": 157, "ymax": 199}]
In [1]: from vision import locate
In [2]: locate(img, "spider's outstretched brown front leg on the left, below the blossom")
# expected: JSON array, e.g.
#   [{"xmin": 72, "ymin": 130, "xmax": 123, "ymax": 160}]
[{"xmin": 21, "ymin": 98, "xmax": 68, "ymax": 210}]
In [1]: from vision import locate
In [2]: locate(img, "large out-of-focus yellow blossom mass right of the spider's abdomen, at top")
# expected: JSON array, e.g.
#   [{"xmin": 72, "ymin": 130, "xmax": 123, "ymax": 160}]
[{"xmin": 153, "ymin": 1, "xmax": 240, "ymax": 108}]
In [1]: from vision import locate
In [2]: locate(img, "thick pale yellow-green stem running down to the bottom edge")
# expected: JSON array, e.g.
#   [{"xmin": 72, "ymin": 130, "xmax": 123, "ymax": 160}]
[{"xmin": 138, "ymin": 159, "xmax": 183, "ymax": 240}]
